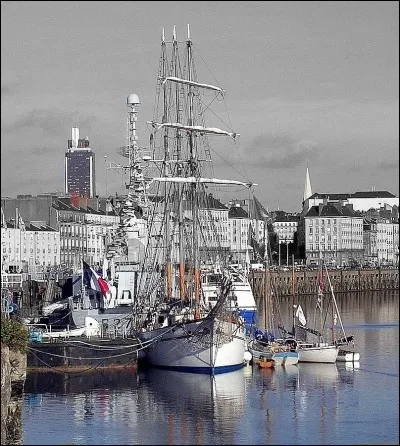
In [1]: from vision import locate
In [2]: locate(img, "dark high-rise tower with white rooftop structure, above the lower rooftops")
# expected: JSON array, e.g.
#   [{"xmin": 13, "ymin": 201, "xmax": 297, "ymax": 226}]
[{"xmin": 65, "ymin": 127, "xmax": 96, "ymax": 198}]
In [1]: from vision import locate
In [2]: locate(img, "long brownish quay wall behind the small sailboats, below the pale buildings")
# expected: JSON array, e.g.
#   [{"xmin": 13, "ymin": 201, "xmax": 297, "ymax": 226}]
[{"xmin": 250, "ymin": 269, "xmax": 399, "ymax": 298}]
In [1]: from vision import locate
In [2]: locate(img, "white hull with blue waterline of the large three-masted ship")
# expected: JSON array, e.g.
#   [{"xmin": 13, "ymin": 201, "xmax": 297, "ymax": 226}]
[{"xmin": 137, "ymin": 318, "xmax": 245, "ymax": 374}]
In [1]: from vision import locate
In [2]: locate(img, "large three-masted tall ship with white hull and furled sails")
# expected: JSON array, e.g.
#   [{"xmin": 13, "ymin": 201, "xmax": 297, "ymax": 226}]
[{"xmin": 126, "ymin": 27, "xmax": 252, "ymax": 374}]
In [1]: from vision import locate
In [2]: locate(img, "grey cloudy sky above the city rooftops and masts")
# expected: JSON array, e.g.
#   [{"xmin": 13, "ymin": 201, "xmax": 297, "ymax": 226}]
[{"xmin": 1, "ymin": 1, "xmax": 399, "ymax": 212}]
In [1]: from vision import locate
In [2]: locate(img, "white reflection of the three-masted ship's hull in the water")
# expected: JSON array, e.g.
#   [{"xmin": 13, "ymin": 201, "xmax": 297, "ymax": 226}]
[{"xmin": 141, "ymin": 369, "xmax": 246, "ymax": 444}]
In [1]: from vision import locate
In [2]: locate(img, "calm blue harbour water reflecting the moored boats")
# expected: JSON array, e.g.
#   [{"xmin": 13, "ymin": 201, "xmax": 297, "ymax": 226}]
[{"xmin": 22, "ymin": 292, "xmax": 399, "ymax": 445}]
